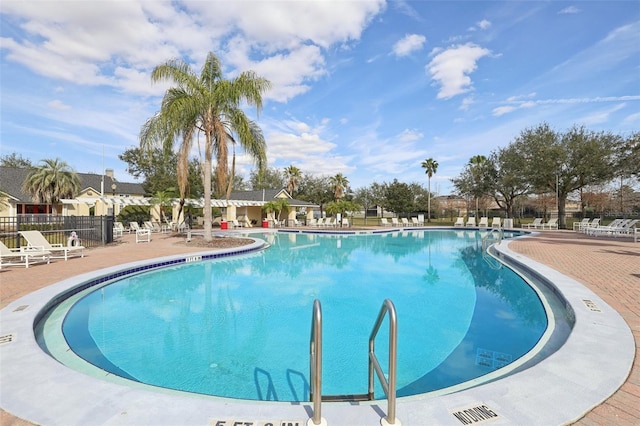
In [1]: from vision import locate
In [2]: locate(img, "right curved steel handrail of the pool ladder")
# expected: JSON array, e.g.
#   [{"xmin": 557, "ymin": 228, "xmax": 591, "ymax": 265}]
[{"xmin": 369, "ymin": 299, "xmax": 398, "ymax": 424}]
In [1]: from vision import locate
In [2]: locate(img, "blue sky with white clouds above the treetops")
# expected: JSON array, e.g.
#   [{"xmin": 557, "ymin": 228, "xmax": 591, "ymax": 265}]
[{"xmin": 0, "ymin": 0, "xmax": 640, "ymax": 194}]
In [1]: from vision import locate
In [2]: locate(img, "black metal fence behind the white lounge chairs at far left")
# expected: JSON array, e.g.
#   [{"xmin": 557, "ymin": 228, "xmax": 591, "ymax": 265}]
[{"xmin": 0, "ymin": 214, "xmax": 114, "ymax": 248}]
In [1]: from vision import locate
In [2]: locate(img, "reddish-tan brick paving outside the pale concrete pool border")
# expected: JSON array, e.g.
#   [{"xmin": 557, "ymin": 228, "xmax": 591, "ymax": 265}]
[{"xmin": 0, "ymin": 231, "xmax": 640, "ymax": 426}]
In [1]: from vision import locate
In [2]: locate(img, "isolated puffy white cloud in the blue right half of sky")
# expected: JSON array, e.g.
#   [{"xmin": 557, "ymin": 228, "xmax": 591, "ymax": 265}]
[{"xmin": 426, "ymin": 43, "xmax": 491, "ymax": 99}]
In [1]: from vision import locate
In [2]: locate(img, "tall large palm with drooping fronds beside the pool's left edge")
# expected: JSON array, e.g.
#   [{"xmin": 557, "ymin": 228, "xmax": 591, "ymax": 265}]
[{"xmin": 140, "ymin": 53, "xmax": 270, "ymax": 241}]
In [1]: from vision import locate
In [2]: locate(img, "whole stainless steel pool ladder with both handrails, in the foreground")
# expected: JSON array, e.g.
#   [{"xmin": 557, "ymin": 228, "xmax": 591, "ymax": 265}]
[{"xmin": 307, "ymin": 299, "xmax": 401, "ymax": 426}]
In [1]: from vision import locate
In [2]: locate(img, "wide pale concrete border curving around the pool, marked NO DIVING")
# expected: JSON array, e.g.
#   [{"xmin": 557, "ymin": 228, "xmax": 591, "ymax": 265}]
[{"xmin": 0, "ymin": 228, "xmax": 635, "ymax": 426}]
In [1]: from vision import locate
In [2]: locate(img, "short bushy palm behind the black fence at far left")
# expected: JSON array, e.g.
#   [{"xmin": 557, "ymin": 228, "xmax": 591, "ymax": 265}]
[{"xmin": 22, "ymin": 158, "xmax": 80, "ymax": 214}]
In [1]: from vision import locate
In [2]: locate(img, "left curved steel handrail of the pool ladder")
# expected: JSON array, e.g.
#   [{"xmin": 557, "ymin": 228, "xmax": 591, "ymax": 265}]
[{"xmin": 309, "ymin": 299, "xmax": 322, "ymax": 425}]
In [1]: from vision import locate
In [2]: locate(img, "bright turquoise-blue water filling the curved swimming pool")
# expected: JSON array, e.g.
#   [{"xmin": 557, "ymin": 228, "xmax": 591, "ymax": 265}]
[{"xmin": 57, "ymin": 230, "xmax": 547, "ymax": 401}]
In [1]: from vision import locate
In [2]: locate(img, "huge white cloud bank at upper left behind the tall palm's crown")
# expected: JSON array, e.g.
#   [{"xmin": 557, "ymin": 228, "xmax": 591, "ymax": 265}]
[{"xmin": 1, "ymin": 0, "xmax": 385, "ymax": 102}]
